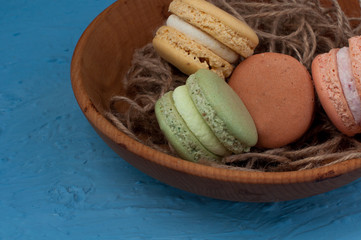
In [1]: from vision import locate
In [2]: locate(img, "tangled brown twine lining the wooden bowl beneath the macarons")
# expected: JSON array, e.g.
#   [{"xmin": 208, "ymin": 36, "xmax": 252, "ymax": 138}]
[{"xmin": 106, "ymin": 0, "xmax": 361, "ymax": 171}]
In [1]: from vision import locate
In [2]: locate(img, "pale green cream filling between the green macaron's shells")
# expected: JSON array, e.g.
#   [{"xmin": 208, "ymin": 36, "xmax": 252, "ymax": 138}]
[{"xmin": 173, "ymin": 85, "xmax": 231, "ymax": 156}]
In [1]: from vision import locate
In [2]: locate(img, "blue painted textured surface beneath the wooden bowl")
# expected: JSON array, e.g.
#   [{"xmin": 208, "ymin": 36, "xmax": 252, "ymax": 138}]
[{"xmin": 0, "ymin": 0, "xmax": 361, "ymax": 240}]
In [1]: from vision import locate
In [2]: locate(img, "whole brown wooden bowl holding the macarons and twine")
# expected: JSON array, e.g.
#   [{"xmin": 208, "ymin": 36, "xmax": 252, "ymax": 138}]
[{"xmin": 71, "ymin": 0, "xmax": 361, "ymax": 202}]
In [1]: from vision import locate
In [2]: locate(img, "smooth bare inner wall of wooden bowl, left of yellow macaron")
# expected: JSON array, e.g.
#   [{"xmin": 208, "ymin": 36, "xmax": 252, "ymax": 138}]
[{"xmin": 76, "ymin": 0, "xmax": 170, "ymax": 113}]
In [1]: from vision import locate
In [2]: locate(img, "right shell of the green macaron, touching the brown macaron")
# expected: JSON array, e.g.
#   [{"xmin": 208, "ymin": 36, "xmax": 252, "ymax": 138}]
[{"xmin": 186, "ymin": 69, "xmax": 257, "ymax": 153}]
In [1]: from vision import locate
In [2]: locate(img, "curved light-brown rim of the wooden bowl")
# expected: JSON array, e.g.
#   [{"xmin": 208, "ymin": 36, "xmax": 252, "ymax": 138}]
[{"xmin": 71, "ymin": 0, "xmax": 361, "ymax": 184}]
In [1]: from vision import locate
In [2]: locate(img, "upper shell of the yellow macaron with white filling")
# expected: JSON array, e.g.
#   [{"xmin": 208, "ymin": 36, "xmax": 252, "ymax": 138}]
[{"xmin": 169, "ymin": 0, "xmax": 259, "ymax": 57}]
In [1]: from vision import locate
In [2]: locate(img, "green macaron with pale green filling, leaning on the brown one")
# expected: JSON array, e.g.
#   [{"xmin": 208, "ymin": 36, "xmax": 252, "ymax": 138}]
[{"xmin": 155, "ymin": 69, "xmax": 257, "ymax": 162}]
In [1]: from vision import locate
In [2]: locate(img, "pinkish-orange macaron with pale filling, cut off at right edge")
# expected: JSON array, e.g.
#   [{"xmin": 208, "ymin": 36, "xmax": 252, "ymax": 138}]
[{"xmin": 312, "ymin": 36, "xmax": 361, "ymax": 136}]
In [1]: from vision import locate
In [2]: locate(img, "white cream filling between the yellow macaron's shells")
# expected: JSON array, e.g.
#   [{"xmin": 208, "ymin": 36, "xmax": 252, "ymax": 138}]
[{"xmin": 166, "ymin": 14, "xmax": 239, "ymax": 63}]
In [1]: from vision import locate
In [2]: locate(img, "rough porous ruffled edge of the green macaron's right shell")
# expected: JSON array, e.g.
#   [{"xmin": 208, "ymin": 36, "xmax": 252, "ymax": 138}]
[{"xmin": 186, "ymin": 75, "xmax": 250, "ymax": 154}]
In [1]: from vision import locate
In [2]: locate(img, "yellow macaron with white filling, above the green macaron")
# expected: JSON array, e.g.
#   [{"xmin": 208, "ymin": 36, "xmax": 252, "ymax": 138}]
[{"xmin": 153, "ymin": 0, "xmax": 259, "ymax": 79}]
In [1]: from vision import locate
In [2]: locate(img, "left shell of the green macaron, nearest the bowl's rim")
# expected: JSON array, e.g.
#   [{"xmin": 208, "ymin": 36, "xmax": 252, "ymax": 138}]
[{"xmin": 155, "ymin": 91, "xmax": 220, "ymax": 162}]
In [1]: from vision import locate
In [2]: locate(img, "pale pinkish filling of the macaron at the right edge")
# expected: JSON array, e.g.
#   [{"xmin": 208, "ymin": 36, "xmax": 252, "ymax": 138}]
[{"xmin": 336, "ymin": 47, "xmax": 361, "ymax": 126}]
